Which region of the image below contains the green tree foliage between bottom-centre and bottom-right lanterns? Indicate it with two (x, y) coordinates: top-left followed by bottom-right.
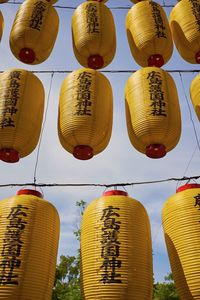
(153, 273), (180, 300)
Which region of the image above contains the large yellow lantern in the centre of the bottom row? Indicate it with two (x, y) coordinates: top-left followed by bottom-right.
(81, 190), (153, 300)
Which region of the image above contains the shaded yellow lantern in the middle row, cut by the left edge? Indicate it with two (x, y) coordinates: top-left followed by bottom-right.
(0, 69), (44, 162)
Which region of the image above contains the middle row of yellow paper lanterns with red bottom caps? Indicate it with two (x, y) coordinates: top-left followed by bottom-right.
(0, 67), (200, 162)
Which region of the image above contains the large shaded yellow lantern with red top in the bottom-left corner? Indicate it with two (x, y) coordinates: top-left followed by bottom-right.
(0, 190), (60, 300)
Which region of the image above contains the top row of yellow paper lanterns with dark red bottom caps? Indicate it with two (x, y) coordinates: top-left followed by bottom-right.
(1, 0), (200, 69)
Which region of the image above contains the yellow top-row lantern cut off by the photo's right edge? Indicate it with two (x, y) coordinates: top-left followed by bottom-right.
(170, 0), (200, 64)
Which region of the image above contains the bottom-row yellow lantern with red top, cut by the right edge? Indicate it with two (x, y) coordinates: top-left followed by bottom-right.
(162, 184), (200, 300)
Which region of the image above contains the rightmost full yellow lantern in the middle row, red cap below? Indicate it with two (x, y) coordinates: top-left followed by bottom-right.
(125, 67), (181, 158)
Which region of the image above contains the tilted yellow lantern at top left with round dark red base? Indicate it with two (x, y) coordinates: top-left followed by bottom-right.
(10, 0), (59, 64)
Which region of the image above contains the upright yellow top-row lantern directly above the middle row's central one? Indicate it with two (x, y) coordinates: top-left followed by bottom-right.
(72, 1), (116, 69)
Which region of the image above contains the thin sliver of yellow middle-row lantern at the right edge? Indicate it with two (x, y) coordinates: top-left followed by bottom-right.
(190, 74), (200, 121)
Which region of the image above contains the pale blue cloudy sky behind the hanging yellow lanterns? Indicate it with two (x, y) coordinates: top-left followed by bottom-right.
(0, 0), (200, 282)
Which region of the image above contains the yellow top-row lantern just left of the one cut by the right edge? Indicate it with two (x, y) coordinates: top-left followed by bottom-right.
(126, 1), (173, 67)
